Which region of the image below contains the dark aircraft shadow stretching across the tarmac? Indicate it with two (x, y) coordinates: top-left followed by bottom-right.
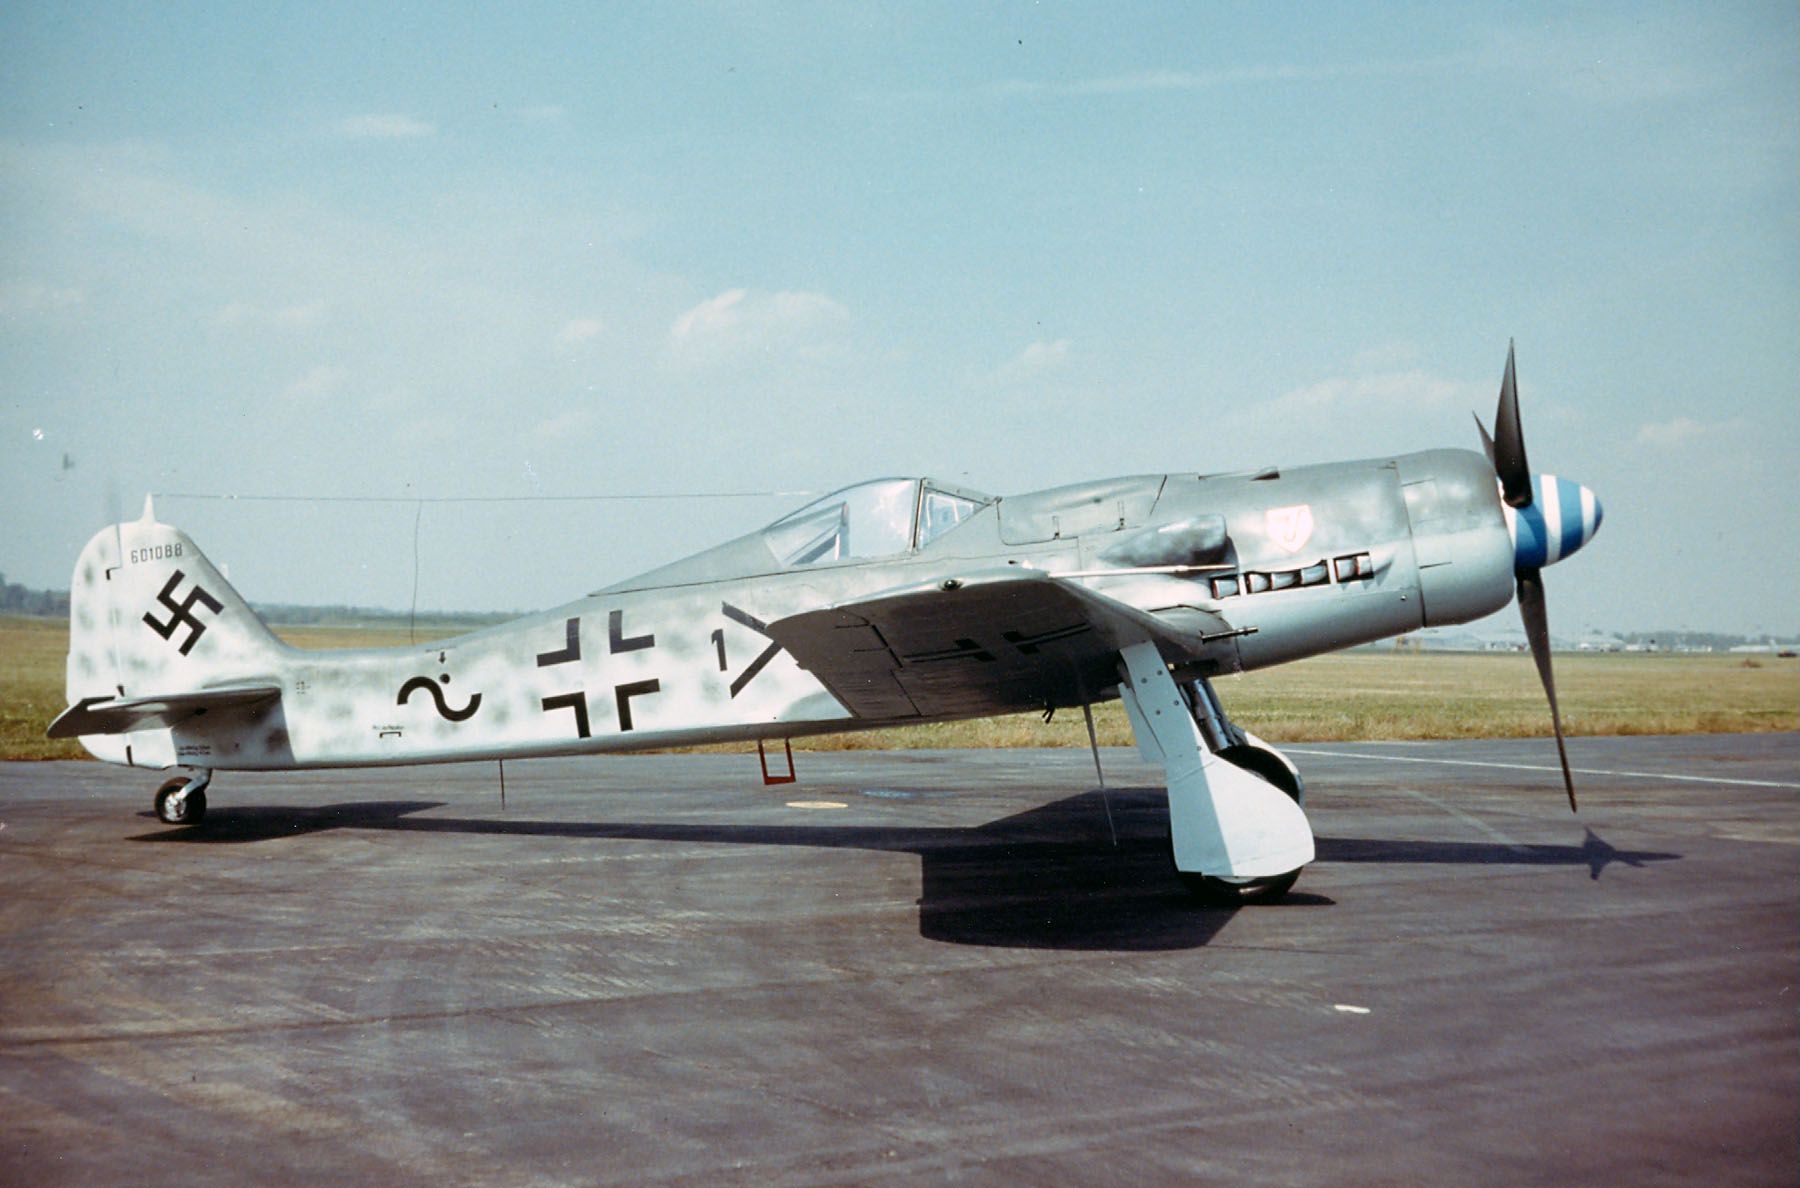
(135, 788), (1681, 950)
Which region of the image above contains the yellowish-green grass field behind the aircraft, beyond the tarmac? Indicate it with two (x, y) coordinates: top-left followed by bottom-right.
(0, 616), (1800, 760)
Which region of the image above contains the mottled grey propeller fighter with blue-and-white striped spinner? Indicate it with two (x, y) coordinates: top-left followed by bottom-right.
(49, 349), (1600, 902)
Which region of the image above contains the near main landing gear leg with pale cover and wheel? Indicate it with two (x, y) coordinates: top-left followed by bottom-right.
(1120, 643), (1312, 905)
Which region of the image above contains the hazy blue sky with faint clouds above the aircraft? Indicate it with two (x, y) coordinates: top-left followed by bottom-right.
(0, 4), (1800, 634)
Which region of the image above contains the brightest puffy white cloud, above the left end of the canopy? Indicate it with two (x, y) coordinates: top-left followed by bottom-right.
(668, 288), (850, 364)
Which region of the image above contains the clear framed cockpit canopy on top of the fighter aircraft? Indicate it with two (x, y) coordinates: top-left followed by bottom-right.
(763, 479), (994, 567)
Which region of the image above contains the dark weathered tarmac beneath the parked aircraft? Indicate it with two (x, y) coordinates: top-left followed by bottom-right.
(0, 734), (1800, 1184)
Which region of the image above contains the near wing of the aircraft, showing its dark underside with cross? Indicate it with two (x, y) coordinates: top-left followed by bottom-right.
(769, 569), (1233, 720)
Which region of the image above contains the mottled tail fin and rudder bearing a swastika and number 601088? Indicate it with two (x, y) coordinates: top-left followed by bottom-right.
(67, 499), (283, 767)
